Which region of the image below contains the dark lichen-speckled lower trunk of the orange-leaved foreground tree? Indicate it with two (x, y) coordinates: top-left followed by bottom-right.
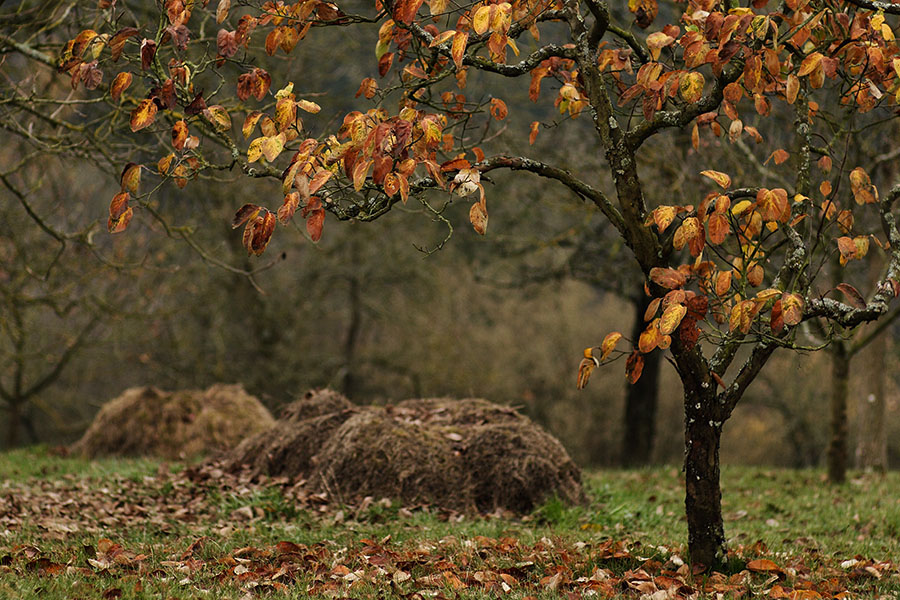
(684, 382), (725, 568)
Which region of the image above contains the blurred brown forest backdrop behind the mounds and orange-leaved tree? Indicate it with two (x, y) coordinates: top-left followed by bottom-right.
(0, 3), (900, 467)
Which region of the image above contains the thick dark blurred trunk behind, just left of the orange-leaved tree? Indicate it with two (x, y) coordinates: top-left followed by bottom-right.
(621, 288), (662, 467)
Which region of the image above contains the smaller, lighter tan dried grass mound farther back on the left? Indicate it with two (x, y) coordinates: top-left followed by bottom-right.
(72, 384), (275, 459)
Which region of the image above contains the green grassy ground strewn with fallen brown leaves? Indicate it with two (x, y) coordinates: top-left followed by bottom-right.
(0, 442), (900, 600)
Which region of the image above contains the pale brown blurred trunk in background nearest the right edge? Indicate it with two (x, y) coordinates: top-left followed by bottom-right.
(856, 332), (888, 473)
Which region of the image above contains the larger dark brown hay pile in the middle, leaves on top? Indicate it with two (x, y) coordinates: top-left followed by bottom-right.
(219, 390), (585, 513)
